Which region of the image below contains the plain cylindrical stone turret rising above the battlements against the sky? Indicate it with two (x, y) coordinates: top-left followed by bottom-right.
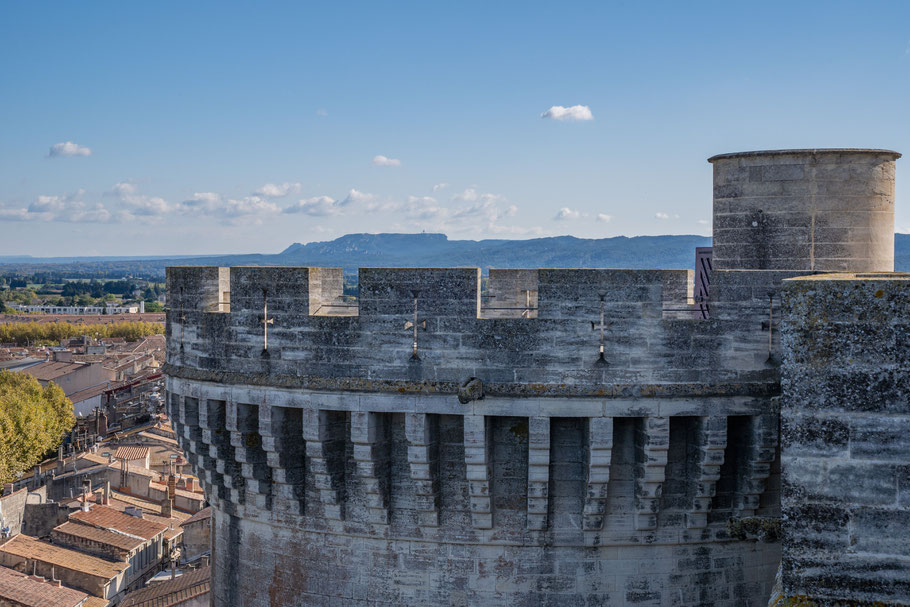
(708, 149), (901, 272)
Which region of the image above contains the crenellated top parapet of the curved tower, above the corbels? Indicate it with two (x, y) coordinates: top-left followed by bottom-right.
(167, 268), (799, 396)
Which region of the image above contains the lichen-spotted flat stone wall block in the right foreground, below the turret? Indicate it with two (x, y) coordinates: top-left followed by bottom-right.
(781, 274), (910, 605)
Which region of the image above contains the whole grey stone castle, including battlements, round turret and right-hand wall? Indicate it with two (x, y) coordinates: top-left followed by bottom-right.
(165, 149), (910, 607)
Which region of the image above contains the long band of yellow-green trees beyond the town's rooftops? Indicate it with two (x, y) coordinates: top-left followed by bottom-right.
(0, 320), (164, 346)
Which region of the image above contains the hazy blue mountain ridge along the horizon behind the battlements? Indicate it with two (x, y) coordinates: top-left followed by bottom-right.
(0, 234), (910, 273)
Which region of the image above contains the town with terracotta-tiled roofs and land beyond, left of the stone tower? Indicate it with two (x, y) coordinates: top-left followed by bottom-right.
(0, 271), (203, 607)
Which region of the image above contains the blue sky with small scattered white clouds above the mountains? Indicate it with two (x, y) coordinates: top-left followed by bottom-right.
(0, 0), (910, 255)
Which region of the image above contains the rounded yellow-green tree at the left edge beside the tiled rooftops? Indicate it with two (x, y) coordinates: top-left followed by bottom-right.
(0, 371), (76, 483)
